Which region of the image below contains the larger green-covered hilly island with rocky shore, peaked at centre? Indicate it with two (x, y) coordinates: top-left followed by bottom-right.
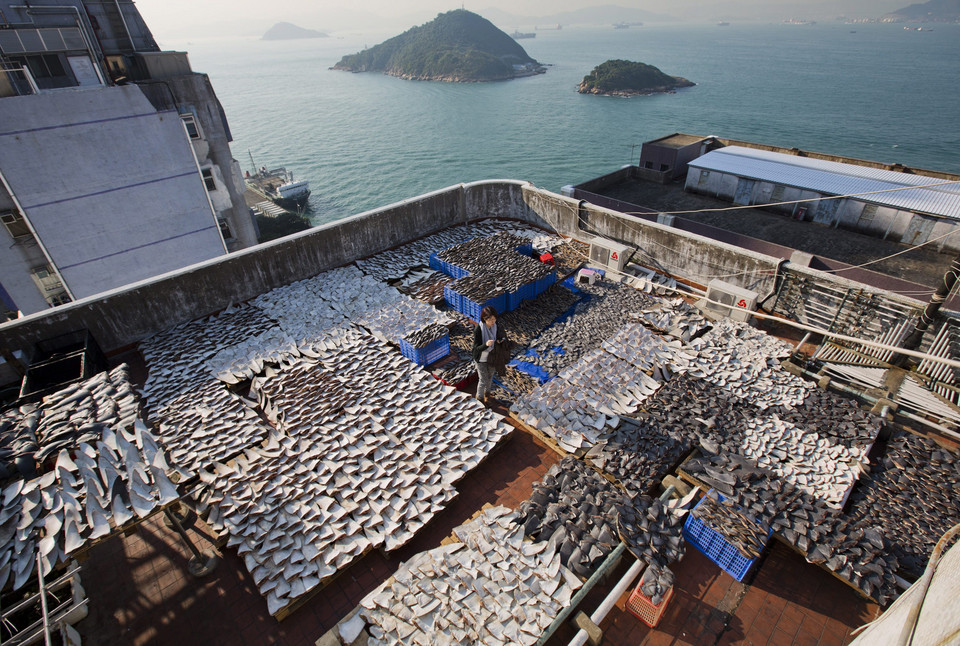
(332, 9), (545, 83)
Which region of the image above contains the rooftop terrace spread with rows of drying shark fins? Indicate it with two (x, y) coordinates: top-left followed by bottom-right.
(0, 183), (960, 644)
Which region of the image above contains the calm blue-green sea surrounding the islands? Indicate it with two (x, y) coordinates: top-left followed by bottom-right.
(172, 23), (960, 224)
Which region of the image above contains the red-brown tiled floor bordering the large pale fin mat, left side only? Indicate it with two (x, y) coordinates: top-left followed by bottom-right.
(77, 418), (560, 646)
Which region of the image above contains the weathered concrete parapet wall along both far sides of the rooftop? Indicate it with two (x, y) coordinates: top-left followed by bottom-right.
(0, 180), (928, 374)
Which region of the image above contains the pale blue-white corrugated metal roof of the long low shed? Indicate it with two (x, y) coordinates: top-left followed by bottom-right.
(688, 146), (960, 219)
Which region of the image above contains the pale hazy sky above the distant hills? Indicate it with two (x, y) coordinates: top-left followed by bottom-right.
(136, 0), (912, 45)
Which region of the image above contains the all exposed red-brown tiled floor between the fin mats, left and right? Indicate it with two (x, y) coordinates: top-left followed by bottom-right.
(77, 365), (878, 646)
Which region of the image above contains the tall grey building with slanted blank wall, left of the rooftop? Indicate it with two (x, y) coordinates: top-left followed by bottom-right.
(0, 0), (257, 320)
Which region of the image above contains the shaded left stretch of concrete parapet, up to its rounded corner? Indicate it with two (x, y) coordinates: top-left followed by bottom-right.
(0, 182), (492, 352)
